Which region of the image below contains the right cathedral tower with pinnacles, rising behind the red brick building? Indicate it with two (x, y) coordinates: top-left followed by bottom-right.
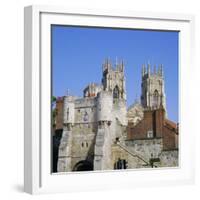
(141, 64), (166, 111)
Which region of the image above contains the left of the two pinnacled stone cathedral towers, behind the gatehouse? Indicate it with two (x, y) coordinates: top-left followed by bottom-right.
(102, 59), (126, 100)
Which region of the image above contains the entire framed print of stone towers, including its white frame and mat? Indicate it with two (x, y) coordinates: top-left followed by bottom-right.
(24, 6), (195, 193)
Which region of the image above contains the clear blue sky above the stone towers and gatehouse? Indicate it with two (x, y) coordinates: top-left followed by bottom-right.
(52, 26), (178, 122)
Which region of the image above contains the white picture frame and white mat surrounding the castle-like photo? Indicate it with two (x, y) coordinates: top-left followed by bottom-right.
(24, 6), (195, 194)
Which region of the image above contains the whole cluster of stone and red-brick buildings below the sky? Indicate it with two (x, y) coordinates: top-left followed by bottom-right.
(54, 59), (178, 172)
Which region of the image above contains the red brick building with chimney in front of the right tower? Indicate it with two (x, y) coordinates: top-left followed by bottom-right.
(127, 108), (178, 150)
